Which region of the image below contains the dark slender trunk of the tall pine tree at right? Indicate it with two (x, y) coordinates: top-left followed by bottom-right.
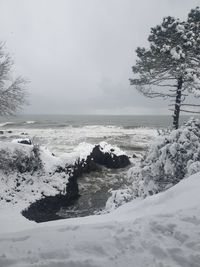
(173, 77), (183, 129)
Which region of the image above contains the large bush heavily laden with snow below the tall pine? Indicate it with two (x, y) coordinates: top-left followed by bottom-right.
(129, 119), (200, 196)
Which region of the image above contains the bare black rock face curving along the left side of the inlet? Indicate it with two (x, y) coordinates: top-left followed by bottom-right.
(22, 145), (130, 222)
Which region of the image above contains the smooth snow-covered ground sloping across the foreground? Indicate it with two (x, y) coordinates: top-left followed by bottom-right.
(0, 173), (200, 267)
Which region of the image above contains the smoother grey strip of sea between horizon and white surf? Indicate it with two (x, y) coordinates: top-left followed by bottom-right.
(0, 115), (195, 128)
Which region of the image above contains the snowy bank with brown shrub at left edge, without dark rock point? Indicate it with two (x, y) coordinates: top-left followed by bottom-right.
(0, 141), (68, 208)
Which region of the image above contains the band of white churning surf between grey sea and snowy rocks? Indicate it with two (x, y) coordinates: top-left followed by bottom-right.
(0, 125), (157, 155)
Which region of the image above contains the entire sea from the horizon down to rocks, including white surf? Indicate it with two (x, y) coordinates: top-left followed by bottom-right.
(0, 115), (195, 155)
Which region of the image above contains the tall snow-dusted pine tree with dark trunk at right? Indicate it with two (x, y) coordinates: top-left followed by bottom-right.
(130, 7), (200, 129)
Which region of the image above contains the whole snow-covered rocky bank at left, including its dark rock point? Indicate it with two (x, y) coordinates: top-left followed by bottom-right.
(0, 139), (130, 211)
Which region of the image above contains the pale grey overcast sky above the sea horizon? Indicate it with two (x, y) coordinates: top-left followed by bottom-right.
(0, 0), (200, 114)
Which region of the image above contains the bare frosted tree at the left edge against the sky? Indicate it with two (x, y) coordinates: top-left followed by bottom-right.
(0, 43), (27, 116)
